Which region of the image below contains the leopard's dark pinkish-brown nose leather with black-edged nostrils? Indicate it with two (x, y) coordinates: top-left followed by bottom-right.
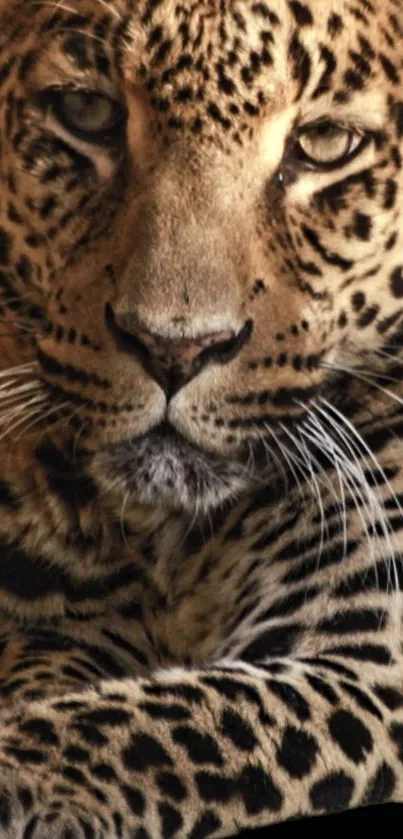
(105, 304), (253, 398)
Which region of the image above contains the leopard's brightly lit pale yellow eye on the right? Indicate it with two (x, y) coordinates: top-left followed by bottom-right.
(298, 122), (365, 169)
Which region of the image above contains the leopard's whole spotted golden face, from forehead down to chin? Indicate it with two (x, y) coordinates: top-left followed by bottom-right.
(0, 0), (403, 511)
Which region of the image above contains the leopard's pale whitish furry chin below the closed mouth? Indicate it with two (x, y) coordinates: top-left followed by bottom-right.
(98, 423), (255, 516)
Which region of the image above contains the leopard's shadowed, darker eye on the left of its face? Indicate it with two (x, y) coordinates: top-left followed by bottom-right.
(42, 89), (125, 144)
